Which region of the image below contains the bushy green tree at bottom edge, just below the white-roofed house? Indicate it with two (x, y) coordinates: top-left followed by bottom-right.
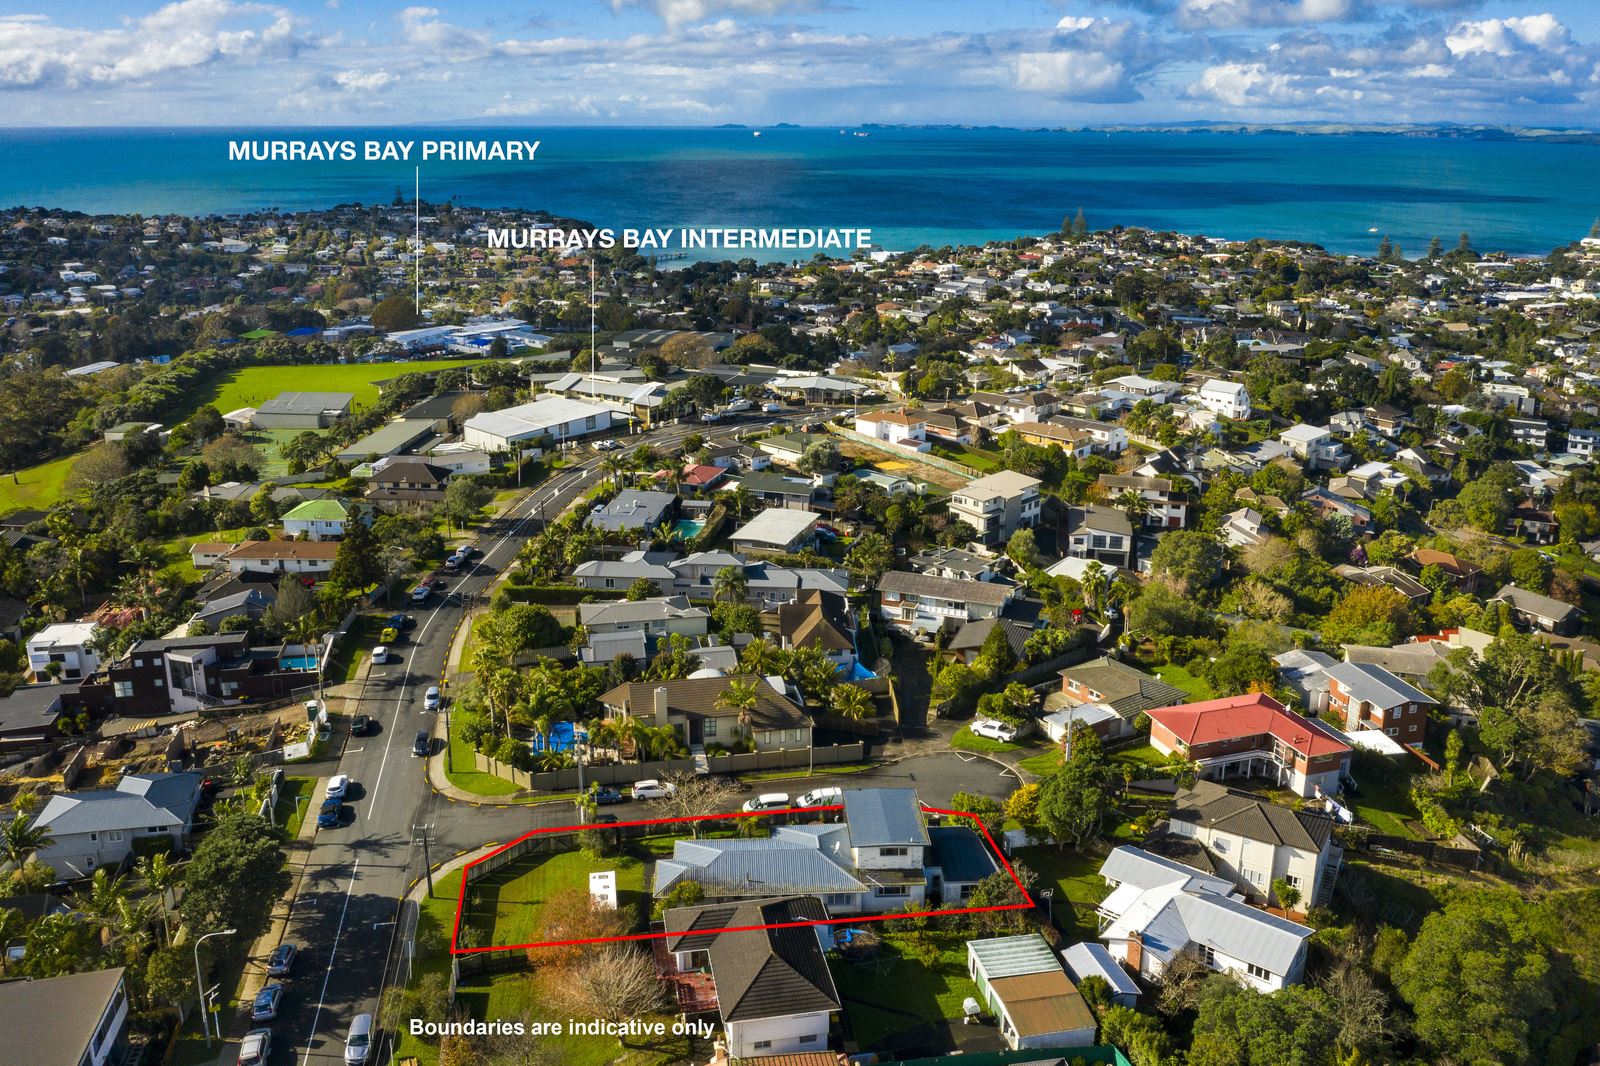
(1184, 975), (1338, 1066)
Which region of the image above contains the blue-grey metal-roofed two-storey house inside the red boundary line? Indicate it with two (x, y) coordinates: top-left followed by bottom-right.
(653, 787), (998, 916)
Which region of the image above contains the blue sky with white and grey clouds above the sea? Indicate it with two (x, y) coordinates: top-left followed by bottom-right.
(0, 0), (1600, 126)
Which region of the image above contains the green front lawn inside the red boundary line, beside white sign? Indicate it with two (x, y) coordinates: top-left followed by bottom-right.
(461, 848), (650, 946)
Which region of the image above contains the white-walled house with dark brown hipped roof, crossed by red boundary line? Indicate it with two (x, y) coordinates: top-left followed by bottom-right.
(664, 896), (840, 1061)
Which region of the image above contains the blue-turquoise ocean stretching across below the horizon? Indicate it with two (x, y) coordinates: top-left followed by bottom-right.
(0, 126), (1600, 254)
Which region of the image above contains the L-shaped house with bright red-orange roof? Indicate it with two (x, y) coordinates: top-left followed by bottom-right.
(1146, 693), (1350, 797)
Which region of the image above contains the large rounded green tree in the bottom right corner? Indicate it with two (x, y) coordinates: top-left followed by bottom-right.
(1392, 890), (1571, 1066)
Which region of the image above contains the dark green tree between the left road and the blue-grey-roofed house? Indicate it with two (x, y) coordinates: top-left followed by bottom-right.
(178, 812), (290, 944)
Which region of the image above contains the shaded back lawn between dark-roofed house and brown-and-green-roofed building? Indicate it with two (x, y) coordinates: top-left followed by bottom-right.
(829, 927), (978, 1050)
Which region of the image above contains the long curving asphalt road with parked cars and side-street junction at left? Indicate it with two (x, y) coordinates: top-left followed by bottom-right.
(265, 410), (832, 1066)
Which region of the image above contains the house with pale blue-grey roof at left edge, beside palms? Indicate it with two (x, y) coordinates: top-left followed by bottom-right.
(32, 773), (200, 880)
